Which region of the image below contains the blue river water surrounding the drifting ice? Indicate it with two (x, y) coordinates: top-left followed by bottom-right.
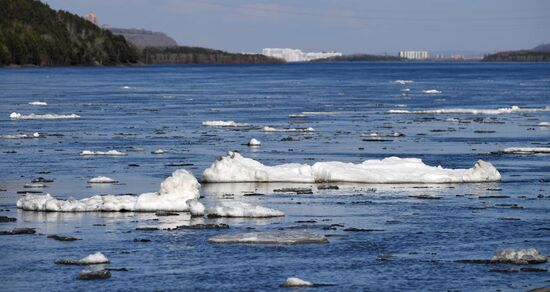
(0, 62), (550, 291)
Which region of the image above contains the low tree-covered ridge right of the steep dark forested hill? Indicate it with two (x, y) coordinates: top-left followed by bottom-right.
(140, 46), (285, 64)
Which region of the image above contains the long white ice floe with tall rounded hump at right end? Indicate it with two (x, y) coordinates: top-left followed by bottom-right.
(17, 169), (200, 212)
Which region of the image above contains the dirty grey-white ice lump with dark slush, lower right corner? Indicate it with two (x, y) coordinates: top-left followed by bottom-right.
(459, 248), (548, 265)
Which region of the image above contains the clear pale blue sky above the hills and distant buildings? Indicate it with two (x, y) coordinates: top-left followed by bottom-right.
(43, 0), (550, 54)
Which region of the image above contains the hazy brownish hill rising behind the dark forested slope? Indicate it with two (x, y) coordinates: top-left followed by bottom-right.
(109, 28), (178, 47)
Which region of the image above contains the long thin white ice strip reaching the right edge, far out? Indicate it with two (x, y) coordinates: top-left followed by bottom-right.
(388, 105), (550, 115)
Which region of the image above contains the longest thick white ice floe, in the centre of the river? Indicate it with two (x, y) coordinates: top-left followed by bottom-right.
(202, 151), (501, 183)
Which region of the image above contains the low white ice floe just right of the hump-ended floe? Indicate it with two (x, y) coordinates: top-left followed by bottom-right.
(206, 202), (285, 218)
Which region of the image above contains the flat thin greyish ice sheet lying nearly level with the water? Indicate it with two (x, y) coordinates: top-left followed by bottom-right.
(208, 231), (328, 244)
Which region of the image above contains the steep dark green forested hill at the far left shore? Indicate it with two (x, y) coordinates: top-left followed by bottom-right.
(0, 0), (138, 66)
